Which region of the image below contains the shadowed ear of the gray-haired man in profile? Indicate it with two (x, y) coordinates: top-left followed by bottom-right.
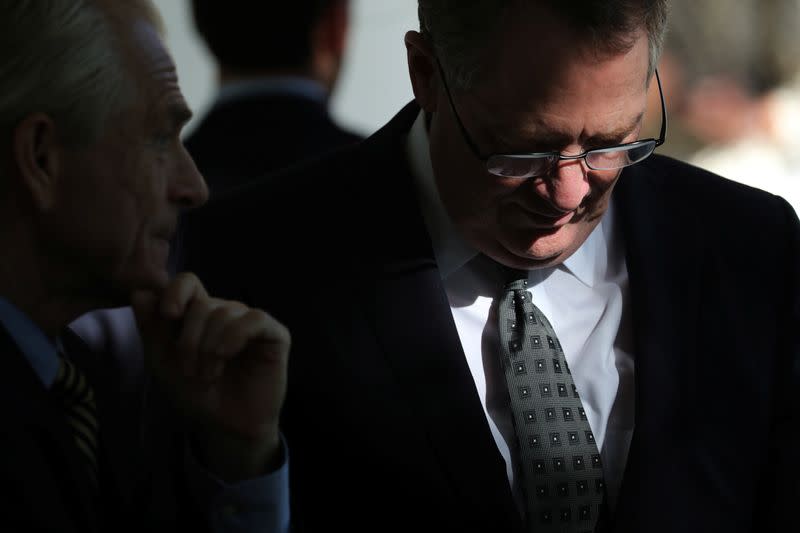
(12, 113), (61, 210)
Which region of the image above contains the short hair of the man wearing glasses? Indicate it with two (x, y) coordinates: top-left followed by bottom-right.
(418, 0), (670, 90)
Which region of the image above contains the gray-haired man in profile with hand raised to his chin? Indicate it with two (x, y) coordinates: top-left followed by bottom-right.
(0, 0), (290, 533)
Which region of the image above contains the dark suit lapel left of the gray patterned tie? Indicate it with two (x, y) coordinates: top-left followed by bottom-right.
(363, 102), (521, 531)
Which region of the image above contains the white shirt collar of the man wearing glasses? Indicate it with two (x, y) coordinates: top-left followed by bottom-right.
(406, 111), (614, 287)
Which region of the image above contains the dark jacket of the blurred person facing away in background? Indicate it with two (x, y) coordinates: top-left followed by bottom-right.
(185, 89), (360, 194)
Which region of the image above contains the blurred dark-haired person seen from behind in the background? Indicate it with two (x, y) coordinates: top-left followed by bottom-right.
(186, 0), (359, 196)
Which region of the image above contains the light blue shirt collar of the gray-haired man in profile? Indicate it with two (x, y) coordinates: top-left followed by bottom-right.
(0, 297), (59, 389)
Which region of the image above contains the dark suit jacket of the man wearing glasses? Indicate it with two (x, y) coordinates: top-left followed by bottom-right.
(185, 104), (800, 533)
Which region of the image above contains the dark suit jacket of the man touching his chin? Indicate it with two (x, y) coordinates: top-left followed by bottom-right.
(0, 326), (204, 533)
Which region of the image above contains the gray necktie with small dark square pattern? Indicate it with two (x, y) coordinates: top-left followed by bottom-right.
(497, 272), (605, 533)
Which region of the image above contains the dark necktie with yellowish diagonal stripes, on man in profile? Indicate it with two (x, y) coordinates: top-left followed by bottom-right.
(52, 354), (97, 486)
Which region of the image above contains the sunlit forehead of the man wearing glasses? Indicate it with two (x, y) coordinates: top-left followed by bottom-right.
(471, 30), (649, 145)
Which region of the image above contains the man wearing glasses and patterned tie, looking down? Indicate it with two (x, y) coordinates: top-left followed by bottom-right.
(186, 0), (800, 533)
